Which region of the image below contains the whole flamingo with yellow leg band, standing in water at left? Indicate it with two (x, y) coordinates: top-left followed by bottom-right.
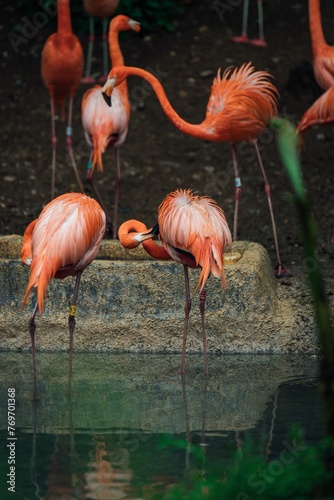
(21, 193), (106, 400)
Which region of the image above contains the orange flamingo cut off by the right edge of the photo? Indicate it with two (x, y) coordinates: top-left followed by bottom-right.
(297, 0), (334, 133)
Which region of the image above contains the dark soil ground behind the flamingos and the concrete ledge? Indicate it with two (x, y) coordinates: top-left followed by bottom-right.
(0, 0), (334, 289)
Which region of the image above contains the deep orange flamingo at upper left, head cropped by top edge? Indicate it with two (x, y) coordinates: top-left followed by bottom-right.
(41, 0), (84, 198)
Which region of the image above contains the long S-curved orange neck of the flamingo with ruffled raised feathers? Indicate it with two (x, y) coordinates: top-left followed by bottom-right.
(115, 66), (215, 141)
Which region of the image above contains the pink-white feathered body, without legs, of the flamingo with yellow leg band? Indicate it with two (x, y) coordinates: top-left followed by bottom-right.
(23, 193), (106, 311)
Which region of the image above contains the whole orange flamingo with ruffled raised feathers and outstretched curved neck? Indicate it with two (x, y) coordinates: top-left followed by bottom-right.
(103, 63), (290, 277)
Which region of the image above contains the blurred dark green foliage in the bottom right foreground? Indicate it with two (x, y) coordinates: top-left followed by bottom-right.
(152, 426), (334, 500)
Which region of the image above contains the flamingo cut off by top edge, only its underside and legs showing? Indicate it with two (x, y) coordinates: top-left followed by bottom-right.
(81, 0), (119, 83)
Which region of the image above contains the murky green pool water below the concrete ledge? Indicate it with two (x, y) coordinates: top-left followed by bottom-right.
(0, 352), (323, 500)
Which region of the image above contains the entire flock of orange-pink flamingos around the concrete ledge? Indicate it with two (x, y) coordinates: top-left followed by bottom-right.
(21, 0), (334, 400)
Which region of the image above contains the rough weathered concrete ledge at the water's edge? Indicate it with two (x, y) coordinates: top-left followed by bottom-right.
(0, 236), (318, 353)
